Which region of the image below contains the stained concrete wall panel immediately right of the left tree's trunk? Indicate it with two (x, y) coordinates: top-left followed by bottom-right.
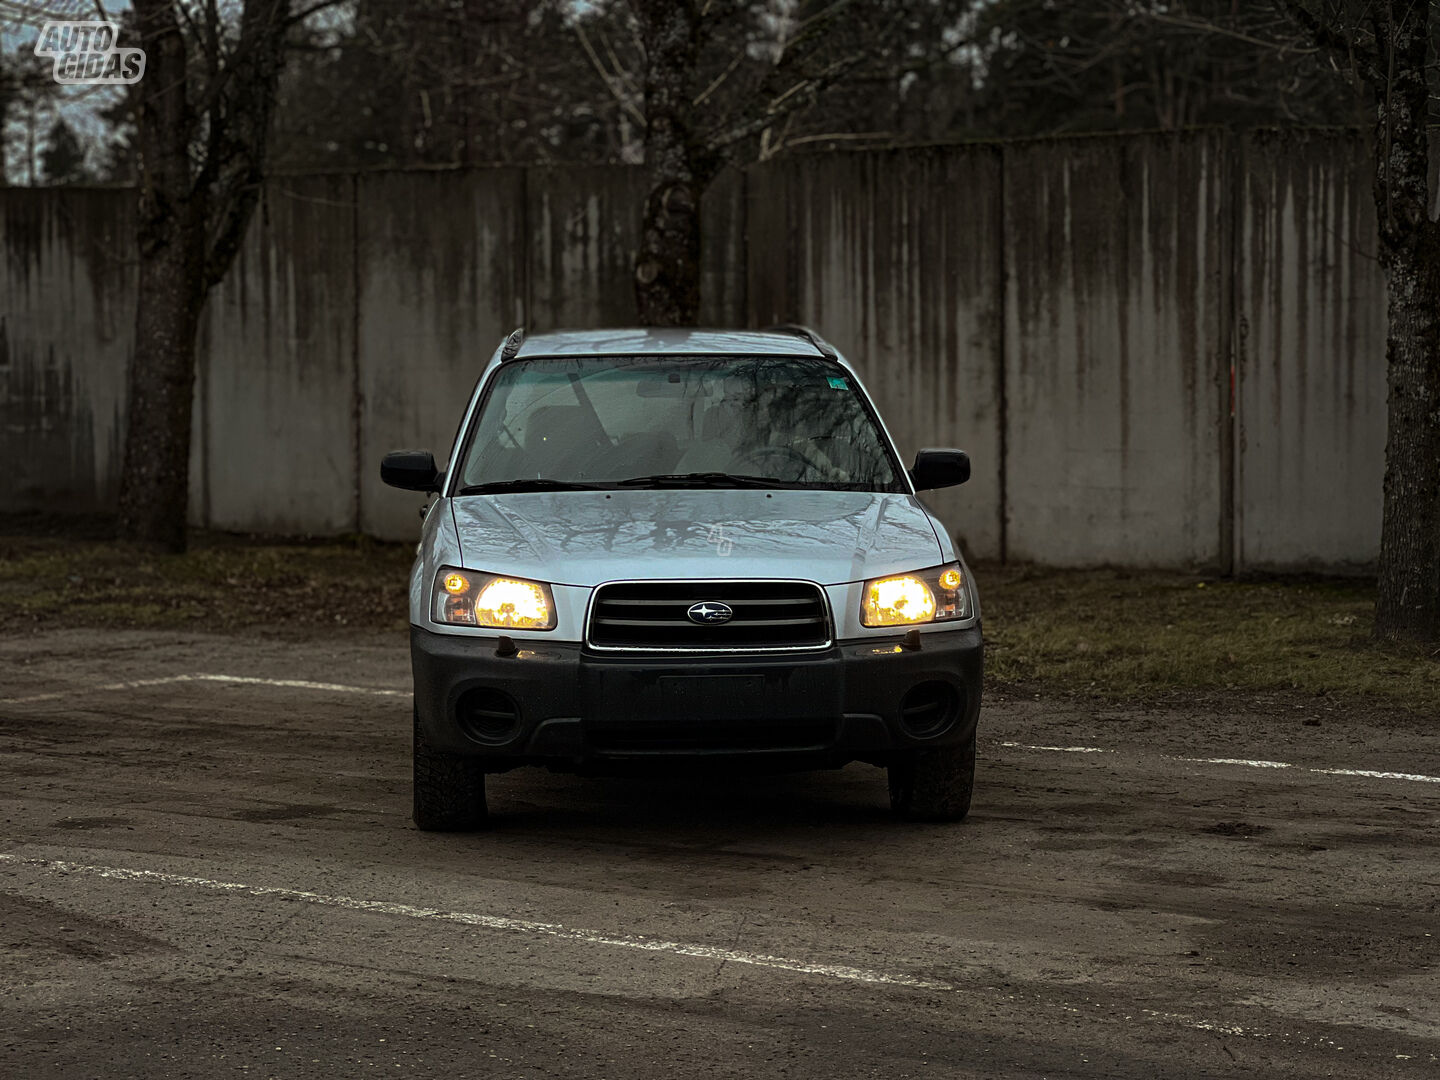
(192, 176), (357, 534)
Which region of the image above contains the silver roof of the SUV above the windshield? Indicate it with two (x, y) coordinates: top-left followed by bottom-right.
(513, 327), (835, 360)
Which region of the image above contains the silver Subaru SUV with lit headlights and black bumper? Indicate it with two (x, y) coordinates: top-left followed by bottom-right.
(380, 327), (982, 829)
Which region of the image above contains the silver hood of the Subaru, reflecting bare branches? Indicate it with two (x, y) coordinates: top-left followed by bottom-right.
(451, 488), (942, 586)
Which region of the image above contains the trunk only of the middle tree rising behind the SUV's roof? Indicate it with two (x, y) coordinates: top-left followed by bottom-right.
(634, 0), (713, 327)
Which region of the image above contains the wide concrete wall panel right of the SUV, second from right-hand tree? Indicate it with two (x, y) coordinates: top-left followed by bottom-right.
(1004, 135), (1230, 566)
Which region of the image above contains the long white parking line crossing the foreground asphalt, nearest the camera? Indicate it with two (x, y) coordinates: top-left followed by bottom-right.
(0, 854), (958, 991)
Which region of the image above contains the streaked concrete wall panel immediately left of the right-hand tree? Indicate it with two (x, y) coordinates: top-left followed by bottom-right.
(1236, 134), (1385, 569)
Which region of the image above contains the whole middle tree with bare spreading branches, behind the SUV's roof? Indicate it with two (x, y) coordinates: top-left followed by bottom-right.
(593, 0), (944, 325)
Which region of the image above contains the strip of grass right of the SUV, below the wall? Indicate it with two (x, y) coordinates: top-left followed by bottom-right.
(978, 566), (1440, 716)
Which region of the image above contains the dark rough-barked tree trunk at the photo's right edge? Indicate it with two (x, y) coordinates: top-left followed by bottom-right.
(1375, 0), (1440, 645)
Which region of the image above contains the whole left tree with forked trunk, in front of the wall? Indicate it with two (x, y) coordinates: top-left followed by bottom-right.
(118, 0), (306, 550)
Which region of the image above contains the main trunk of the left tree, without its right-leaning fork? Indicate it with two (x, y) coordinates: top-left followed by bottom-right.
(118, 0), (206, 552)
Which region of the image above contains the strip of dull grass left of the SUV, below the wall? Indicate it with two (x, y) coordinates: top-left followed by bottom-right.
(0, 528), (415, 632)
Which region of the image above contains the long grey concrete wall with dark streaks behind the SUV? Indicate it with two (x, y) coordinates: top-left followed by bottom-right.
(0, 132), (1385, 569)
